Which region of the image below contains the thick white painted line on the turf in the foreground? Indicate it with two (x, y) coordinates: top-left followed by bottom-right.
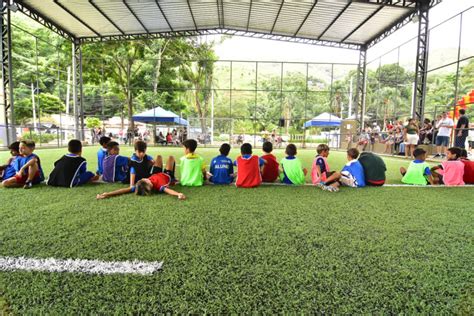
(0, 257), (163, 275)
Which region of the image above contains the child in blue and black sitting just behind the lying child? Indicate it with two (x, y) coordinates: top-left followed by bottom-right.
(122, 140), (156, 186)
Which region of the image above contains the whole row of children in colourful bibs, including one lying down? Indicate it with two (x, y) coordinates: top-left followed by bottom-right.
(0, 136), (474, 199)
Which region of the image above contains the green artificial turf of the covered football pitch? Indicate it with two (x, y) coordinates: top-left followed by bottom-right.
(0, 148), (474, 314)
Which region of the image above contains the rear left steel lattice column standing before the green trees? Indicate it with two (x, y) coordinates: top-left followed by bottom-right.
(72, 40), (84, 141)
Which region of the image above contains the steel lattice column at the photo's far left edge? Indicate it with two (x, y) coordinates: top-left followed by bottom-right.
(0, 0), (16, 146)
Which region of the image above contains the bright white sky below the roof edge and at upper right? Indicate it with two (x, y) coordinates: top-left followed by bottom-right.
(209, 0), (474, 63)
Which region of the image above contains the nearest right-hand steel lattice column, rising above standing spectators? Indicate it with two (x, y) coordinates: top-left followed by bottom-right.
(412, 0), (430, 121)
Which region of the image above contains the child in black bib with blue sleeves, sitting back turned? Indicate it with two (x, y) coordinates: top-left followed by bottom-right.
(48, 139), (99, 188)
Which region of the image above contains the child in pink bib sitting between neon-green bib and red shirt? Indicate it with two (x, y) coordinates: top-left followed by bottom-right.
(431, 147), (464, 186)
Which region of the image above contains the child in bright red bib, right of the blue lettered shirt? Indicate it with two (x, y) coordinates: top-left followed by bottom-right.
(234, 143), (265, 188)
